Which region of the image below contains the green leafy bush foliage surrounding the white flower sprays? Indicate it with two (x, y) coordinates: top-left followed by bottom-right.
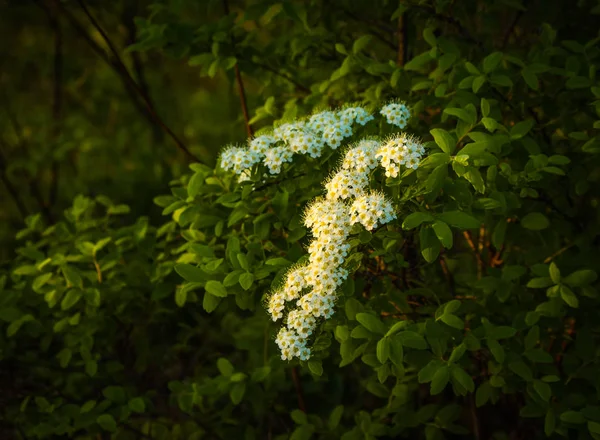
(0, 1), (600, 440)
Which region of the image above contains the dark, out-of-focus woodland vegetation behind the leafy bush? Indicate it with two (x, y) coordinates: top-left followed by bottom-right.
(0, 0), (597, 260)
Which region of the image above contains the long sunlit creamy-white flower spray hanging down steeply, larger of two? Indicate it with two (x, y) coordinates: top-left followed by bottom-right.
(268, 135), (423, 360)
